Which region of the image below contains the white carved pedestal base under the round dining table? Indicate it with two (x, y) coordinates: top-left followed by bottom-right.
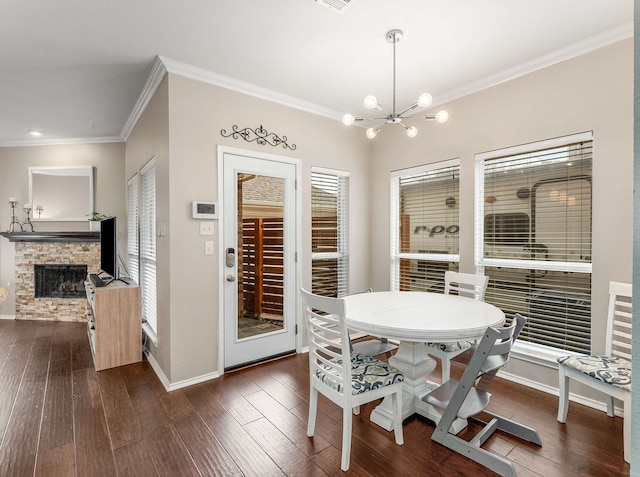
(371, 341), (467, 434)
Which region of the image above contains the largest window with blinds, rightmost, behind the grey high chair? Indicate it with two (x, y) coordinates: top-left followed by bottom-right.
(475, 133), (592, 353)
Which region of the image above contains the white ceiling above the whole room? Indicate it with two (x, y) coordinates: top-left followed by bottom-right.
(0, 0), (633, 146)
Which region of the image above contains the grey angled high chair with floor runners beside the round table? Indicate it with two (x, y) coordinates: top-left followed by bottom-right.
(423, 315), (542, 477)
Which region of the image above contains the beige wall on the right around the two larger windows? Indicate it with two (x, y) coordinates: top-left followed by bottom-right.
(370, 40), (633, 390)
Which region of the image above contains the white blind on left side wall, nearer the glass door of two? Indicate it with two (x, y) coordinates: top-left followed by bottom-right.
(140, 159), (158, 333)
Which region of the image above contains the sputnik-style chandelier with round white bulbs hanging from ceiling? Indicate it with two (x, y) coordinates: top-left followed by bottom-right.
(342, 30), (449, 139)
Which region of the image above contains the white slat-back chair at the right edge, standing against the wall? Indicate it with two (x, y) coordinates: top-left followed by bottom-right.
(558, 282), (632, 462)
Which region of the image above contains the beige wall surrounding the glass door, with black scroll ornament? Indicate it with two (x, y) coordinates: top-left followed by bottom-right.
(127, 74), (371, 385)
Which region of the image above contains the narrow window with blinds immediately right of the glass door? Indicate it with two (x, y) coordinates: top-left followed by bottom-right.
(311, 168), (349, 297)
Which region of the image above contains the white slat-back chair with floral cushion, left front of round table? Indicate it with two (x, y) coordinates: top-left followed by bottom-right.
(300, 289), (404, 471)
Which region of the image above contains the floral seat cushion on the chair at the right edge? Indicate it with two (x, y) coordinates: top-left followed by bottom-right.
(558, 356), (631, 391)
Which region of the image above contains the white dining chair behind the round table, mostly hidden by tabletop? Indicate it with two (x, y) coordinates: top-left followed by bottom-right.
(427, 270), (489, 383)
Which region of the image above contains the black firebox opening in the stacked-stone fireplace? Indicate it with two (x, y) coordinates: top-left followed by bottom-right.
(33, 264), (87, 298)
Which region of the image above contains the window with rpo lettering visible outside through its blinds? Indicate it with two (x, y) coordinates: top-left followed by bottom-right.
(391, 159), (460, 292)
